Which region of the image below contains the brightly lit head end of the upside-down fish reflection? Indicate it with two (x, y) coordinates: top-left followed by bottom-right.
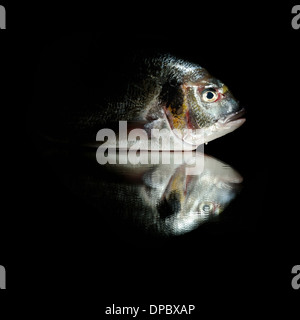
(132, 153), (242, 235)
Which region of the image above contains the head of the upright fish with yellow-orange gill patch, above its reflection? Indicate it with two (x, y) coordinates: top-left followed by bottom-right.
(165, 67), (245, 146)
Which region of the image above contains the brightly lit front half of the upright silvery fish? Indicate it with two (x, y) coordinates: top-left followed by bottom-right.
(94, 55), (245, 150)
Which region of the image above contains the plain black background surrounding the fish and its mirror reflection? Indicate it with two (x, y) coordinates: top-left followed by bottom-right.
(0, 2), (300, 317)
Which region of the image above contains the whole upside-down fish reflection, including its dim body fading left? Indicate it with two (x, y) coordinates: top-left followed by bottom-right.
(46, 152), (242, 236)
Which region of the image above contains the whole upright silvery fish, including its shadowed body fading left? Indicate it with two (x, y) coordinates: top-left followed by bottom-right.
(32, 42), (245, 150)
